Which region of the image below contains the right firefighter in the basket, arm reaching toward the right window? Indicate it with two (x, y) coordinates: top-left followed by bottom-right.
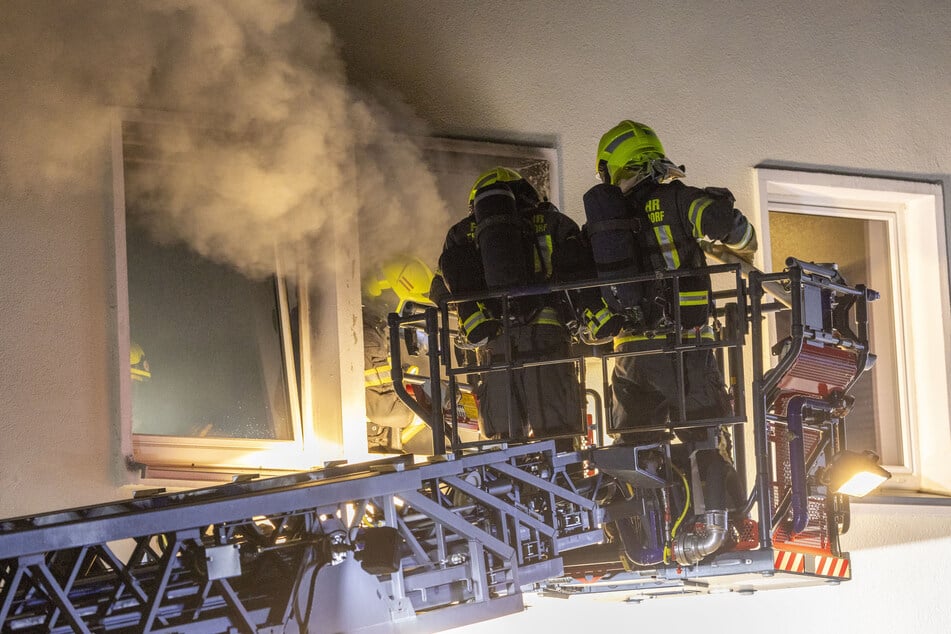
(584, 120), (757, 508)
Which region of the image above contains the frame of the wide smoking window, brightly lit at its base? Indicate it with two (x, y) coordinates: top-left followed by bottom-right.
(112, 109), (561, 486)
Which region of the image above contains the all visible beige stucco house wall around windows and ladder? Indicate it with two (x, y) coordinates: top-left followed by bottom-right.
(0, 0), (951, 632)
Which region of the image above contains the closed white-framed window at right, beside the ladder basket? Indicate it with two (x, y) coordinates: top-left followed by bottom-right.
(758, 169), (951, 494)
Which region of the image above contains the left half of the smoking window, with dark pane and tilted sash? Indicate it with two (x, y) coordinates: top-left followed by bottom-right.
(113, 112), (309, 479)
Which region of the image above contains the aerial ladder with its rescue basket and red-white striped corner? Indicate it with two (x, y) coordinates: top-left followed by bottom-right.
(0, 259), (875, 634)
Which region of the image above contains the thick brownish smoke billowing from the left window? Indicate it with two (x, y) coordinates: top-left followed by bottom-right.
(0, 0), (448, 277)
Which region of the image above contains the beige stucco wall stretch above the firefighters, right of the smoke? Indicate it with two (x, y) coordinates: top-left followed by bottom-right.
(318, 0), (951, 222)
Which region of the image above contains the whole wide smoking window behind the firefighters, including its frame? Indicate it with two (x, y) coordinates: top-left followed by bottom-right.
(113, 111), (558, 480)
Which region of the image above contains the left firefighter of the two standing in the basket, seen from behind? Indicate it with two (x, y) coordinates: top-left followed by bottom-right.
(430, 167), (622, 450)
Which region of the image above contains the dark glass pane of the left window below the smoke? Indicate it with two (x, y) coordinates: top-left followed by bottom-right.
(126, 163), (294, 440)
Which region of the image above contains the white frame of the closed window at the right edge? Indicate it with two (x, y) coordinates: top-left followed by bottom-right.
(755, 169), (951, 494)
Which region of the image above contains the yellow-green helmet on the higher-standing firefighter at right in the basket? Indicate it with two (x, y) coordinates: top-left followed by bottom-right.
(597, 119), (667, 185)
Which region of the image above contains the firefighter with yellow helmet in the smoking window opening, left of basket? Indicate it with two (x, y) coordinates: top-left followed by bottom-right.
(363, 256), (433, 453)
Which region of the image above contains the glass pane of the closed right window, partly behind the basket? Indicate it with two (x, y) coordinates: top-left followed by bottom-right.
(769, 211), (903, 465)
